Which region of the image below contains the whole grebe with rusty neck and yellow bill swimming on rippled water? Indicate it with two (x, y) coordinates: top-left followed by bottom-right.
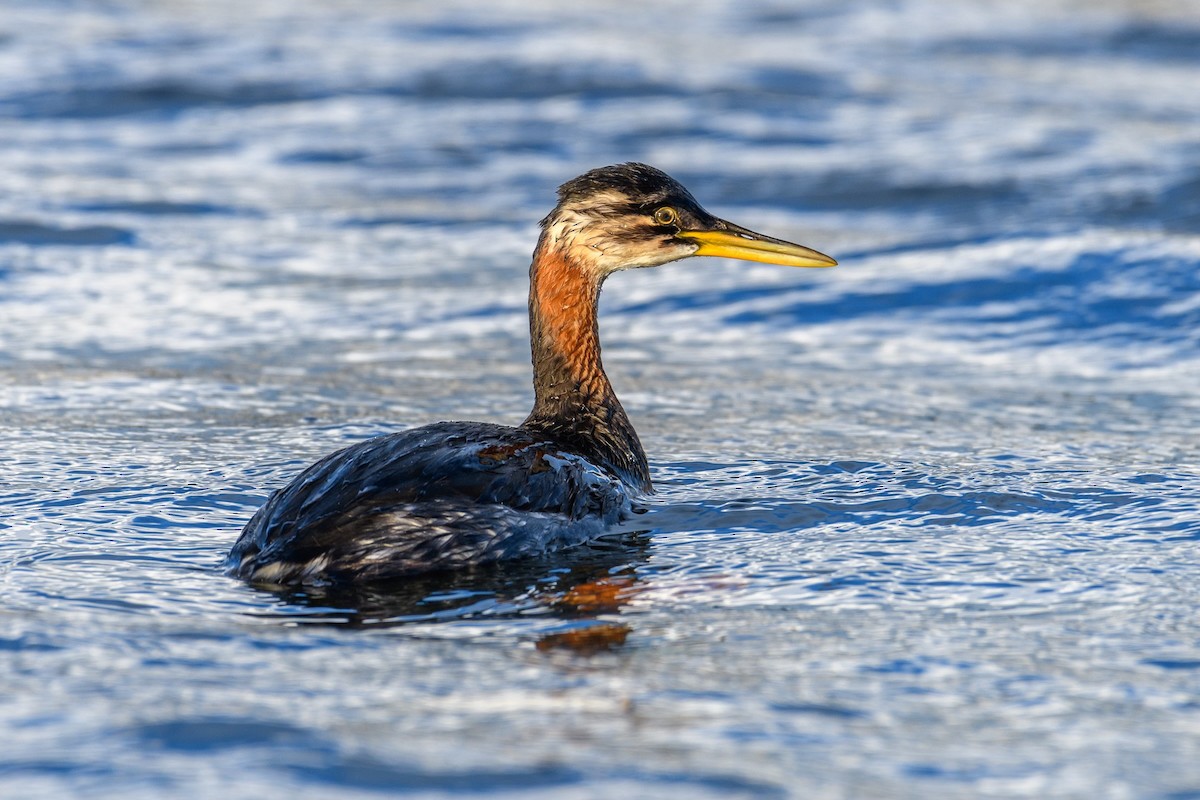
(226, 163), (836, 584)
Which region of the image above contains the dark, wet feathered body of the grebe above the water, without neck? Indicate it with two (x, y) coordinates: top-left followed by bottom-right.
(226, 422), (630, 583)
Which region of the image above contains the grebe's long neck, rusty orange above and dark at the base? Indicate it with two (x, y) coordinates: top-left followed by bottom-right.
(522, 234), (650, 491)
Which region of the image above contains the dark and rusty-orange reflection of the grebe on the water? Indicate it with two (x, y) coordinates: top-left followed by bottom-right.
(247, 531), (649, 655)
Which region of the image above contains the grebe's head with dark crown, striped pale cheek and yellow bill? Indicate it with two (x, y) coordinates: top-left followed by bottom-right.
(541, 163), (838, 279)
